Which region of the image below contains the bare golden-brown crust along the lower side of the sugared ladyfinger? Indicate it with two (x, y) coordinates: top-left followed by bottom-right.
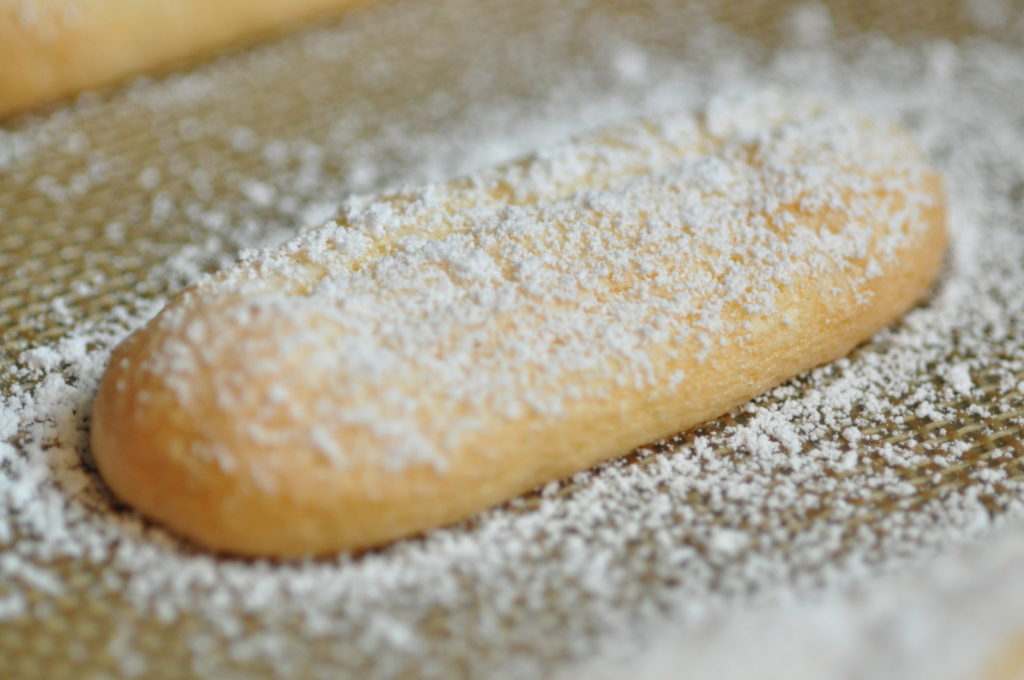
(92, 96), (946, 556)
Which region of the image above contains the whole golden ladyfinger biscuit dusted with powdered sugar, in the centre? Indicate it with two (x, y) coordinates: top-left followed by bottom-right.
(92, 94), (946, 556)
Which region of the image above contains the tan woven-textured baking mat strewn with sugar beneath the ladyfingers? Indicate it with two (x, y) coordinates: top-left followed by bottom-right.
(0, 0), (1024, 678)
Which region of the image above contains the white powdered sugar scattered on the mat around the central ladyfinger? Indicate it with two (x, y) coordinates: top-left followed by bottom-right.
(0, 0), (1024, 677)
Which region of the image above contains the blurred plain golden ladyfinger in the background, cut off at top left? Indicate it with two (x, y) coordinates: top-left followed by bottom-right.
(0, 0), (360, 117)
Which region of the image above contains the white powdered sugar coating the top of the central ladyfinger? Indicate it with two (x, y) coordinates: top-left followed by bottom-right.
(121, 94), (938, 475)
